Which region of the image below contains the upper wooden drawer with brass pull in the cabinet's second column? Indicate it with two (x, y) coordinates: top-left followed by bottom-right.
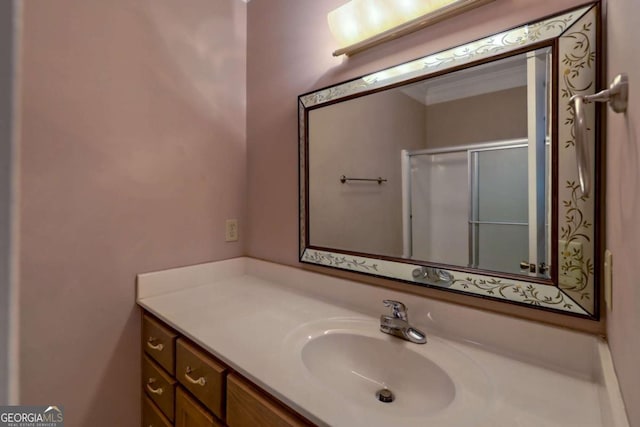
(176, 338), (227, 419)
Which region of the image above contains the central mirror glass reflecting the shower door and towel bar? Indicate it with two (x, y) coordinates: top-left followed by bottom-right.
(308, 47), (551, 278)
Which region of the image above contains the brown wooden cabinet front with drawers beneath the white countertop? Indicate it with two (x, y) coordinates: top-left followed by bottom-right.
(142, 312), (314, 427)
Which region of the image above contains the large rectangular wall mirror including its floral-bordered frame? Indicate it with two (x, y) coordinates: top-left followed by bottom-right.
(299, 4), (600, 318)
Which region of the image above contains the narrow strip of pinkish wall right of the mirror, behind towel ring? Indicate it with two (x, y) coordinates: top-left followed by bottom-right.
(607, 0), (640, 427)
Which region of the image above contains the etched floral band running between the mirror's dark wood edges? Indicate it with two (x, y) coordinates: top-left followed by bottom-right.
(298, 4), (598, 317)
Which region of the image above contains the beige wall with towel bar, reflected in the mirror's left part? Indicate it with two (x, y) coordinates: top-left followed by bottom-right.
(308, 90), (425, 256)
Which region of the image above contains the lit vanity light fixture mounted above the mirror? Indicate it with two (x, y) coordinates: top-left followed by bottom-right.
(327, 0), (494, 56)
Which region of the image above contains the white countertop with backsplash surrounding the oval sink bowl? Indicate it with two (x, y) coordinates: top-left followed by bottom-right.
(138, 258), (627, 427)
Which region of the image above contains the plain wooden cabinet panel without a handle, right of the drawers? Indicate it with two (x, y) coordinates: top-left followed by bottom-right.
(227, 374), (313, 427)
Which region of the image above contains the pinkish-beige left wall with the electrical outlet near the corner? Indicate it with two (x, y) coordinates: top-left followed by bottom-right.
(20, 0), (246, 427)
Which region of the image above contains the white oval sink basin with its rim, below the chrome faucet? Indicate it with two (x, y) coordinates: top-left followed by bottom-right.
(284, 318), (494, 427)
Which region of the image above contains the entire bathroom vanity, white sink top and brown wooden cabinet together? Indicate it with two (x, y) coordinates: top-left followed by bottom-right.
(137, 258), (628, 427)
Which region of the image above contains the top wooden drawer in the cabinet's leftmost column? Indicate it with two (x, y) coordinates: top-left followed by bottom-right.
(142, 314), (177, 375)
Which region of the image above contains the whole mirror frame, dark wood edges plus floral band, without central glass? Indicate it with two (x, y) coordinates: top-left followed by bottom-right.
(298, 3), (604, 320)
